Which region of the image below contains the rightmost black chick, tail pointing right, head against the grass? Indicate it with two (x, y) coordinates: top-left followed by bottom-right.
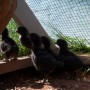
(56, 39), (86, 79)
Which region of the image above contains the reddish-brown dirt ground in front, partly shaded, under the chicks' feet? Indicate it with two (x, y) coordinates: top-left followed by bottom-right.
(0, 67), (90, 90)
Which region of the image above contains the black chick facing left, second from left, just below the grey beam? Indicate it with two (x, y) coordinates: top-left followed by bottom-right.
(16, 26), (32, 49)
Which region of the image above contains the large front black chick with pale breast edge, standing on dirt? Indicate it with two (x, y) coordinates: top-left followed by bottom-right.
(30, 33), (61, 83)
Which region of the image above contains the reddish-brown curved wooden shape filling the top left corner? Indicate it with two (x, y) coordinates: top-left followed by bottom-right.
(0, 0), (17, 33)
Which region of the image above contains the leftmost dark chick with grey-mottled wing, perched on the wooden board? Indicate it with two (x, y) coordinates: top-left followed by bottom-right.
(0, 28), (19, 61)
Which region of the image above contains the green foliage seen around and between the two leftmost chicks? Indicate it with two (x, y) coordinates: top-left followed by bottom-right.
(0, 19), (30, 59)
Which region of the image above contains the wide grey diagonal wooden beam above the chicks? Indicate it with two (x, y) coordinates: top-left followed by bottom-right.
(14, 0), (48, 36)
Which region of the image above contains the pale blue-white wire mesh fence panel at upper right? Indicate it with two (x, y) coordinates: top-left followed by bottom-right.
(25, 0), (90, 44)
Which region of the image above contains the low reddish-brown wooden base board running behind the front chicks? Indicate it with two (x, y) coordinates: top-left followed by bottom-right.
(0, 55), (90, 75)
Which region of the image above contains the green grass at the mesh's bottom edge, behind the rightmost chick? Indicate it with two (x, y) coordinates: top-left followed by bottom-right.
(51, 26), (90, 53)
